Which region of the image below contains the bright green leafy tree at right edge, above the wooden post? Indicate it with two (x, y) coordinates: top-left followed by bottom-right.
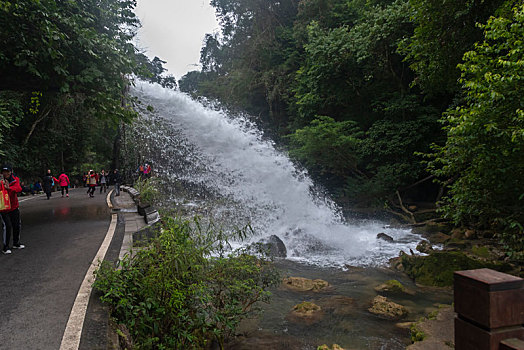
(429, 5), (524, 252)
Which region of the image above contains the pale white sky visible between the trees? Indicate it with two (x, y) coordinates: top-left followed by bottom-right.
(135, 0), (219, 80)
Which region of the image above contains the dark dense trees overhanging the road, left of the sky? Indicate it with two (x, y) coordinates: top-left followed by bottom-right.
(0, 0), (176, 179)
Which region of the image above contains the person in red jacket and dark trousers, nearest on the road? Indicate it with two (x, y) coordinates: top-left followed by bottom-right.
(0, 165), (25, 254)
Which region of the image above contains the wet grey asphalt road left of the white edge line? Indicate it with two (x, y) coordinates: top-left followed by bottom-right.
(0, 188), (116, 349)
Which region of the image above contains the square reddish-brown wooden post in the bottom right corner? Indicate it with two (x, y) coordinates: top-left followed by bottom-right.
(454, 269), (524, 350)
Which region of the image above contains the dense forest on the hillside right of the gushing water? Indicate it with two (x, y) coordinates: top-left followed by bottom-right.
(179, 0), (524, 258)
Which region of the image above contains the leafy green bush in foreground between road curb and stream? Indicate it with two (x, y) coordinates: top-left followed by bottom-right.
(94, 219), (279, 349)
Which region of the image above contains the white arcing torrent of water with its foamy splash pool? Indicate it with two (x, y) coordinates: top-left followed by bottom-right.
(133, 82), (420, 267)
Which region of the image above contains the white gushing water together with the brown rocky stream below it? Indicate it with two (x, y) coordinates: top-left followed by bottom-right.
(126, 81), (452, 350)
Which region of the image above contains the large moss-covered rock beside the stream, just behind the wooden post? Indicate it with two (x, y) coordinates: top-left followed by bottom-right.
(401, 251), (512, 287)
